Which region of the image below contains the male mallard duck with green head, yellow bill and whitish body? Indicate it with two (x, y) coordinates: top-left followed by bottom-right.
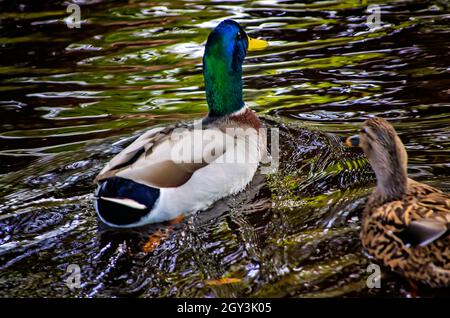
(91, 20), (267, 227)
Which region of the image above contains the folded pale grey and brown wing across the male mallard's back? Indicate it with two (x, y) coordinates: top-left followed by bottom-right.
(95, 124), (226, 188)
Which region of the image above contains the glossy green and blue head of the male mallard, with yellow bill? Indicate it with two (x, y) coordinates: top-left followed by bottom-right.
(203, 20), (267, 117)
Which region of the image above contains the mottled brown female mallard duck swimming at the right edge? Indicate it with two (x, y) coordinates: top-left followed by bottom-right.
(346, 118), (450, 287)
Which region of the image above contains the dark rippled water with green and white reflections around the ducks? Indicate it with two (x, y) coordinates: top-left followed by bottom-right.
(0, 0), (450, 297)
